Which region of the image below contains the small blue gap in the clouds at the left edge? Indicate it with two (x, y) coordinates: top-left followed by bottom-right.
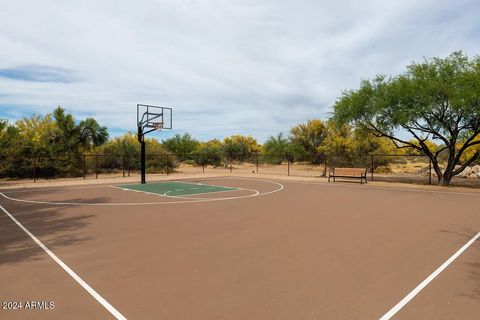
(0, 65), (76, 83)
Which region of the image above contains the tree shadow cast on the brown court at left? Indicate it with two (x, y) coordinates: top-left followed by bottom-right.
(0, 198), (105, 265)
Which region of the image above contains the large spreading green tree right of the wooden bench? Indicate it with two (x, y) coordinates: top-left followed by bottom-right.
(333, 52), (480, 186)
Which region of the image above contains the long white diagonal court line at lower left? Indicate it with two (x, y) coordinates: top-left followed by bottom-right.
(0, 205), (127, 320)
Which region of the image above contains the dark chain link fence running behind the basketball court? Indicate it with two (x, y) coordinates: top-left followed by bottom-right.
(0, 153), (480, 187)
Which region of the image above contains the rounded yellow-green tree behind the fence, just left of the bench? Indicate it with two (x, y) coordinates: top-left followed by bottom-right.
(290, 119), (327, 164)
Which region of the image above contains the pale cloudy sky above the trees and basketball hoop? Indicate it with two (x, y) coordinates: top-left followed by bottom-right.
(0, 0), (480, 142)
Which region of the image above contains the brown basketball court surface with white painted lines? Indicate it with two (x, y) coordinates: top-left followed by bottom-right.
(0, 177), (480, 319)
